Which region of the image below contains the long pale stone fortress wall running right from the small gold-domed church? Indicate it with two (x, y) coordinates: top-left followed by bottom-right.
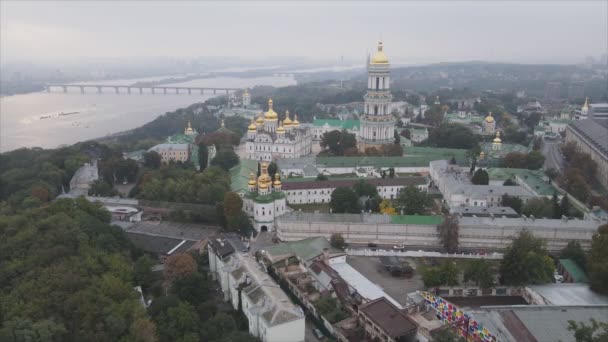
(276, 214), (601, 251)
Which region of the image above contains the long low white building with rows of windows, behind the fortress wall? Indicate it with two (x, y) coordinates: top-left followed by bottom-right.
(283, 177), (429, 204)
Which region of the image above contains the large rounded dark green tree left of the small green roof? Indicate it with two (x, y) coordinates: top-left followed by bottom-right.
(500, 230), (555, 286)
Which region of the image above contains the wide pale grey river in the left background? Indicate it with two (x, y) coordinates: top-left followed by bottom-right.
(0, 76), (296, 152)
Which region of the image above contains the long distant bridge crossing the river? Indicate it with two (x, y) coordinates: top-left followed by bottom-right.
(45, 84), (239, 95)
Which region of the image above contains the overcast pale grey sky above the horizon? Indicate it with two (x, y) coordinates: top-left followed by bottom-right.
(0, 0), (608, 63)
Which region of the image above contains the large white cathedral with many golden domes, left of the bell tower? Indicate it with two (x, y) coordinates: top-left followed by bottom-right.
(245, 99), (312, 162)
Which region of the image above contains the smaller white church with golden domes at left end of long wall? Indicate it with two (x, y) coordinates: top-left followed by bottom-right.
(243, 162), (287, 231)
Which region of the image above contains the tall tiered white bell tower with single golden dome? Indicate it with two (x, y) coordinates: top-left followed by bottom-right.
(358, 42), (396, 151)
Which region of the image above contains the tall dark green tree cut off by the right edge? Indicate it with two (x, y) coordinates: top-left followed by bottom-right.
(587, 224), (608, 294)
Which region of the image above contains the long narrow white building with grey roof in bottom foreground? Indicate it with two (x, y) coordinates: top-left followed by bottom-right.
(208, 237), (306, 342)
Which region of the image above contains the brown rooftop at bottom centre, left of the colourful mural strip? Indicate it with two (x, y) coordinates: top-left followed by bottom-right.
(359, 297), (417, 339)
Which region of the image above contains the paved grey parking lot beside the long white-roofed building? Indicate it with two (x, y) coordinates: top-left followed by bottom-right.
(346, 256), (424, 305)
